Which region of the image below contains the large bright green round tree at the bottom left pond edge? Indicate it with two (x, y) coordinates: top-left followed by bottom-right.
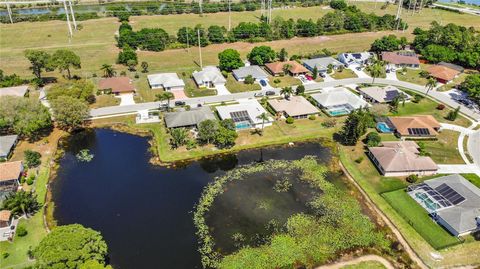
(33, 224), (108, 269)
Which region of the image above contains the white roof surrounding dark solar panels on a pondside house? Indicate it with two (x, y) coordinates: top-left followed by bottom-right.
(216, 99), (273, 124)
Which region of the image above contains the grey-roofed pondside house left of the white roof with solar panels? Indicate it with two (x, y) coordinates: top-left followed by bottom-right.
(165, 106), (215, 128)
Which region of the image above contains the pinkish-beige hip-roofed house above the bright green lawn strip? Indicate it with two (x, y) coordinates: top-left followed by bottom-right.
(368, 141), (438, 177)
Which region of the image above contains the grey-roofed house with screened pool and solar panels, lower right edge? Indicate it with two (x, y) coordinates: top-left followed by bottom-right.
(407, 174), (480, 236)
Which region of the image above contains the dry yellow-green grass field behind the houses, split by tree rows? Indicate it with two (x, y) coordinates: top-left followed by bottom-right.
(0, 2), (480, 77)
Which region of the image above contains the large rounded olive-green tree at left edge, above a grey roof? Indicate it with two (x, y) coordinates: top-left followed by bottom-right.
(0, 96), (52, 138)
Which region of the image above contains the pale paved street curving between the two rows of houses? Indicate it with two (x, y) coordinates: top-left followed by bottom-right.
(90, 78), (480, 121)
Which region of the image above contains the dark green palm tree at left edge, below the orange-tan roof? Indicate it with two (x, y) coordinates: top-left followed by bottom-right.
(2, 190), (41, 218)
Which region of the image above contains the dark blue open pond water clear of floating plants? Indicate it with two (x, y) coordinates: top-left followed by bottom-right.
(52, 129), (330, 269)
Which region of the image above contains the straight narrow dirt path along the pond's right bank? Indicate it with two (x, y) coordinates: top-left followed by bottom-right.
(338, 159), (428, 269)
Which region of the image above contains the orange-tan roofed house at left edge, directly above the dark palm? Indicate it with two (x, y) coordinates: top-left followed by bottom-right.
(0, 161), (23, 201)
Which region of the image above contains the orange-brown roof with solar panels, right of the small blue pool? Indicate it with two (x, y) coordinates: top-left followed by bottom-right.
(388, 115), (440, 136)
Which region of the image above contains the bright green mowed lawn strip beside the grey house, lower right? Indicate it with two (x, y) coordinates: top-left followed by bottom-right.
(382, 189), (460, 249)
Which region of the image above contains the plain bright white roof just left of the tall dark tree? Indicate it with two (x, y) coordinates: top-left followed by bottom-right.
(311, 88), (368, 109)
